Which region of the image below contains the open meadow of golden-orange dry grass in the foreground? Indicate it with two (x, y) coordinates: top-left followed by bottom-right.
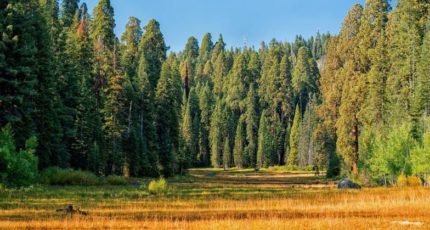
(0, 170), (430, 229)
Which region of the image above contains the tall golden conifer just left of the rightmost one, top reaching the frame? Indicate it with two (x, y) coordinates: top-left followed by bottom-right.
(357, 0), (390, 129)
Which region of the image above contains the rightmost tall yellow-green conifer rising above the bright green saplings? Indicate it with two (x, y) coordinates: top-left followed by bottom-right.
(385, 0), (424, 123)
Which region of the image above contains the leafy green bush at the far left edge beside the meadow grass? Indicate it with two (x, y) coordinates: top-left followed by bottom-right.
(0, 125), (38, 187)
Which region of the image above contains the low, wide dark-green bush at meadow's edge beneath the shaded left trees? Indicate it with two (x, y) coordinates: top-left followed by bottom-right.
(40, 167), (100, 186)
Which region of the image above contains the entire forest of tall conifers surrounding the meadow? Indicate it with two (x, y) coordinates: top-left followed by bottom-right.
(0, 0), (430, 185)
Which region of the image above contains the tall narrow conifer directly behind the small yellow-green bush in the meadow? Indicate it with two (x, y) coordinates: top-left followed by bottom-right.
(155, 54), (182, 176)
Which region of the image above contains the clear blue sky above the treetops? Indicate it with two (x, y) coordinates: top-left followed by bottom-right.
(81, 0), (364, 51)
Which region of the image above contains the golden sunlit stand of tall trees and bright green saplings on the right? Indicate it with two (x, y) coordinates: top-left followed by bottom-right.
(317, 0), (430, 183)
